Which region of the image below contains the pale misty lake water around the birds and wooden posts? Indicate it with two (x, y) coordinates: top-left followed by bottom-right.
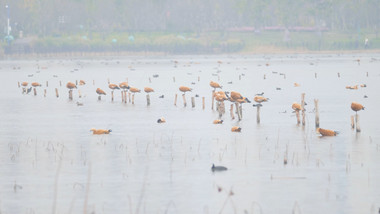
(0, 54), (380, 213)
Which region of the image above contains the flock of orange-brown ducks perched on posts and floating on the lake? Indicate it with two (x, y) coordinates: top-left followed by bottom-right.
(21, 77), (366, 136)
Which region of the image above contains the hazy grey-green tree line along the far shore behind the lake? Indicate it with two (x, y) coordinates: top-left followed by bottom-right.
(0, 0), (380, 36)
